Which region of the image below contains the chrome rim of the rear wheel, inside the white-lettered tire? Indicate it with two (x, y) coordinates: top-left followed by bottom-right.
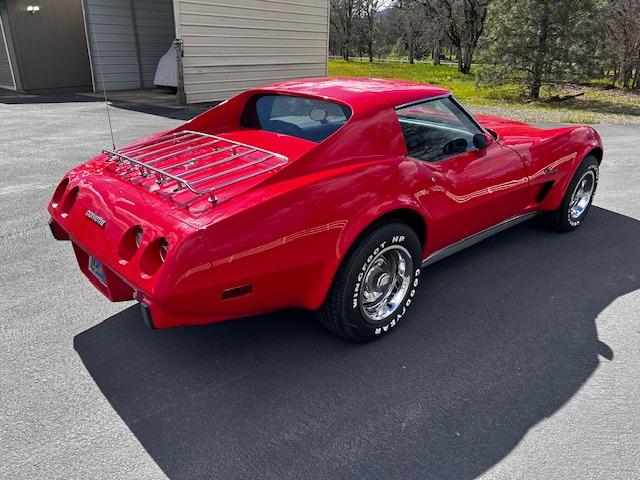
(358, 245), (413, 322)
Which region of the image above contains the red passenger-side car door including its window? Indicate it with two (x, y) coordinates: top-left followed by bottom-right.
(396, 97), (530, 253)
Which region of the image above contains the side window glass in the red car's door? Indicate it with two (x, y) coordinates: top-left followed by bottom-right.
(396, 97), (480, 162)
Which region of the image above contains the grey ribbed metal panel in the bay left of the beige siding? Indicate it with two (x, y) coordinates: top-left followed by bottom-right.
(83, 0), (175, 91)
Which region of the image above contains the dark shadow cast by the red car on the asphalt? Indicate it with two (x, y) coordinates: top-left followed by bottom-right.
(74, 207), (640, 480)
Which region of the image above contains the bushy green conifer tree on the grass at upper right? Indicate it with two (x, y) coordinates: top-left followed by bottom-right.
(478, 0), (599, 99)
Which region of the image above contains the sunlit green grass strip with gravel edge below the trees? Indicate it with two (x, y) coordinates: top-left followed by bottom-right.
(329, 60), (640, 123)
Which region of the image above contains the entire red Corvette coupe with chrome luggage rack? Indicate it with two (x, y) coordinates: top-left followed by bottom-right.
(49, 78), (602, 341)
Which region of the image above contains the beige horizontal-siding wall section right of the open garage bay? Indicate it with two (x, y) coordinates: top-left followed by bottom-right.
(174, 0), (329, 103)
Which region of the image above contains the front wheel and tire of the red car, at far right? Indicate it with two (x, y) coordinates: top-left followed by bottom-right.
(544, 155), (599, 232)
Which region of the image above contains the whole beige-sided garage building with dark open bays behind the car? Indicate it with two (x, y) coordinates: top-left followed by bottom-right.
(0, 0), (329, 103)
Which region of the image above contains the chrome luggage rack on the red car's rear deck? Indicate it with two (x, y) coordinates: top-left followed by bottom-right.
(102, 130), (289, 207)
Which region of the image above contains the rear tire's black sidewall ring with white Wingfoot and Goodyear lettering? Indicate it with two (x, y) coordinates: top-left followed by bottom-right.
(343, 223), (422, 339)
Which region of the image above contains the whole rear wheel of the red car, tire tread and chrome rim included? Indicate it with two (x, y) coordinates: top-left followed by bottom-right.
(317, 222), (422, 342)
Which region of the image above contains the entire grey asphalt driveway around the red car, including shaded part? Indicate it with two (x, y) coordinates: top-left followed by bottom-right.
(0, 98), (640, 480)
